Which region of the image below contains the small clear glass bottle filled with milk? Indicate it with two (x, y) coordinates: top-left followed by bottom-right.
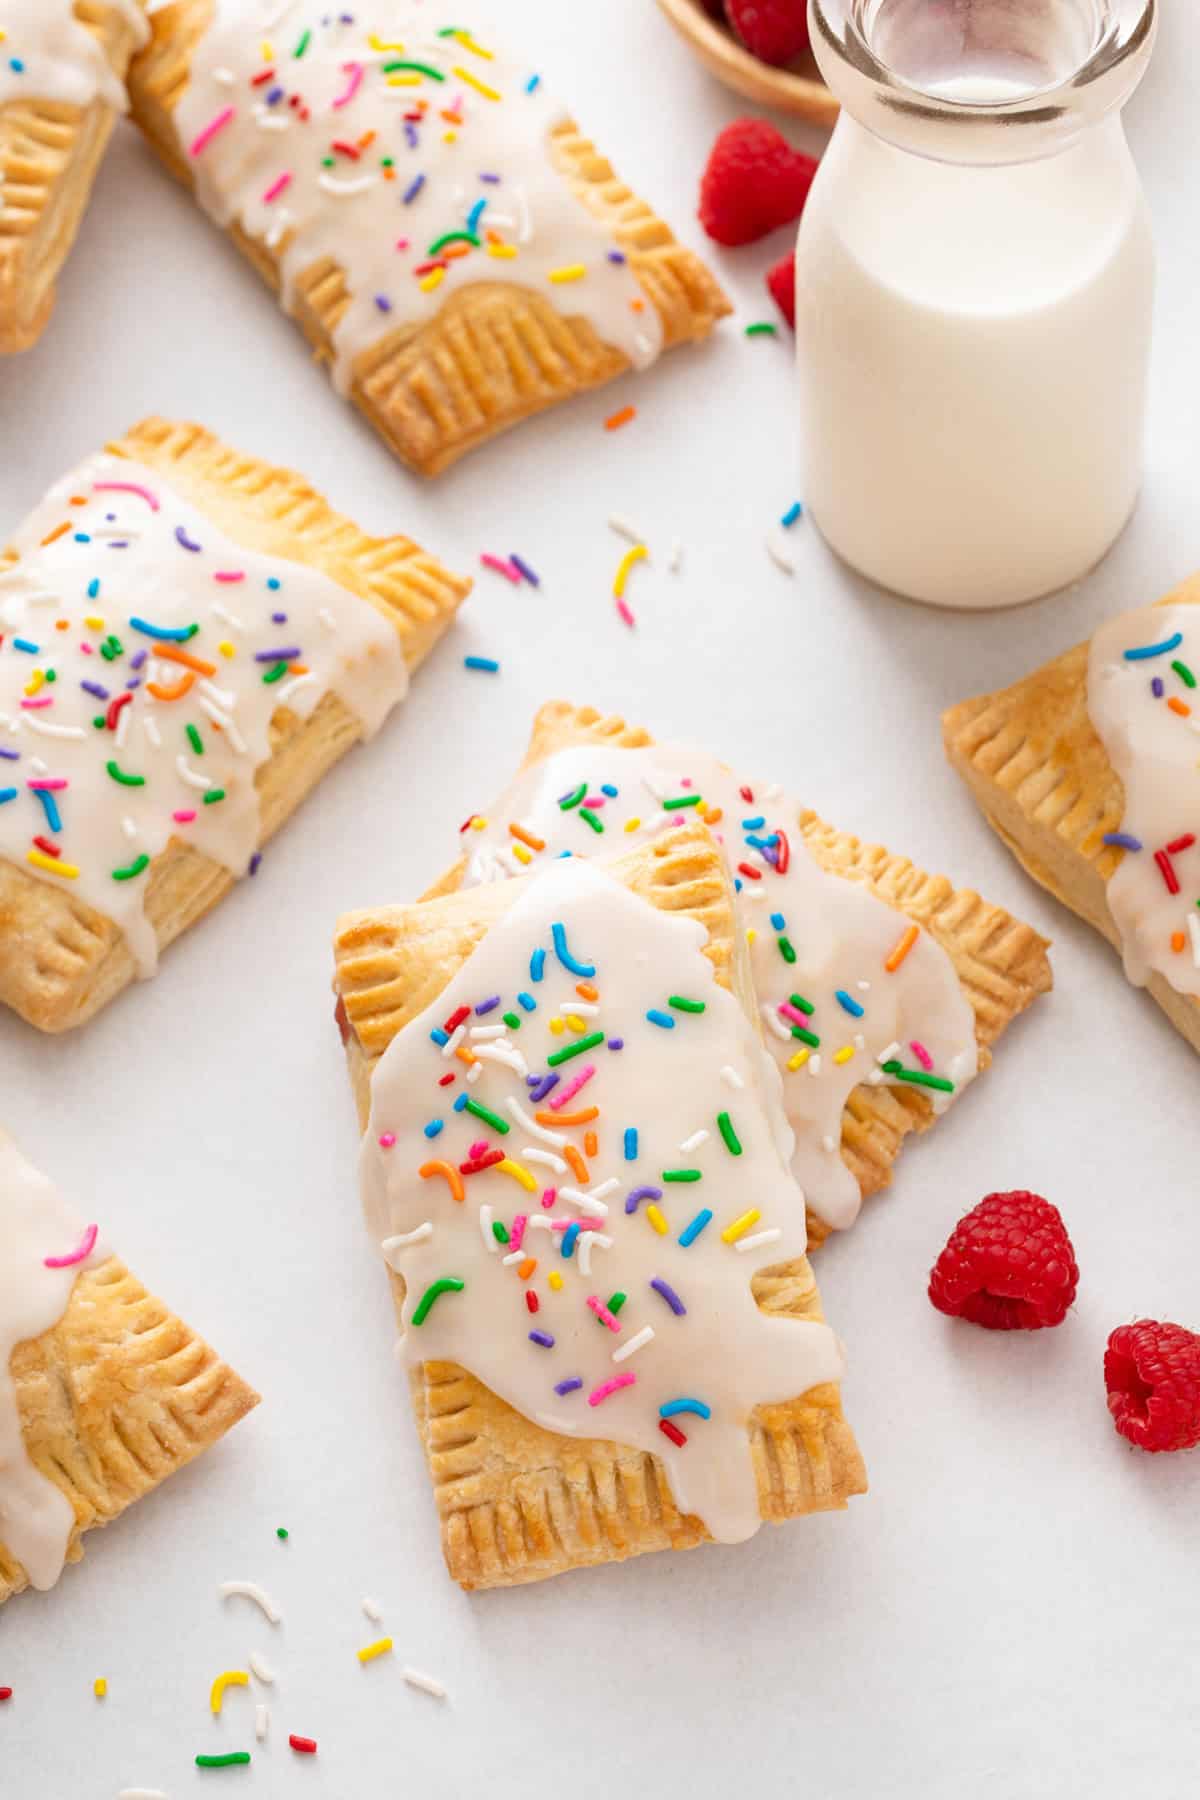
(795, 0), (1157, 607)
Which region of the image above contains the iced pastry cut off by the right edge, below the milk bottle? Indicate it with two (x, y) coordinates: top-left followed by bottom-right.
(943, 576), (1200, 1049)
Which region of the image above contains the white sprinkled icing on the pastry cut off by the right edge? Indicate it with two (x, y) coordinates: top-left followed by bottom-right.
(1087, 607), (1200, 995)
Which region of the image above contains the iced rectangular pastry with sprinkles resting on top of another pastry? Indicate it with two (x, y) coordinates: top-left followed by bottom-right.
(335, 821), (865, 1588)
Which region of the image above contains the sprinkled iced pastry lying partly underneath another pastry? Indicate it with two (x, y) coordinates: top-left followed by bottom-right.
(434, 702), (1051, 1244)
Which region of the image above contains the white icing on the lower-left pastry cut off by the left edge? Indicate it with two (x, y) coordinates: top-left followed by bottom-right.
(0, 1132), (108, 1588)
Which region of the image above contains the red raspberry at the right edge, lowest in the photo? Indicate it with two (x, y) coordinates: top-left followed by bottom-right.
(1105, 1319), (1200, 1451)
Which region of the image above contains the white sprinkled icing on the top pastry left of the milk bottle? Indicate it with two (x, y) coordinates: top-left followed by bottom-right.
(175, 0), (662, 392)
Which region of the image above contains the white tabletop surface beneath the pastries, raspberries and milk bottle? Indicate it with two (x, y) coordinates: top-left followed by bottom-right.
(0, 0), (1200, 1800)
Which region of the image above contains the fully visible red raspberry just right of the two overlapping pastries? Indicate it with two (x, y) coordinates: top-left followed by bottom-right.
(928, 1190), (1079, 1332)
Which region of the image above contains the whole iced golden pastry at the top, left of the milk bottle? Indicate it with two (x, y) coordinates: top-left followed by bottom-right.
(130, 0), (729, 475)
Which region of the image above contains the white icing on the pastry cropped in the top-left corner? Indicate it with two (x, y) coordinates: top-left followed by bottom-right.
(0, 0), (149, 112)
